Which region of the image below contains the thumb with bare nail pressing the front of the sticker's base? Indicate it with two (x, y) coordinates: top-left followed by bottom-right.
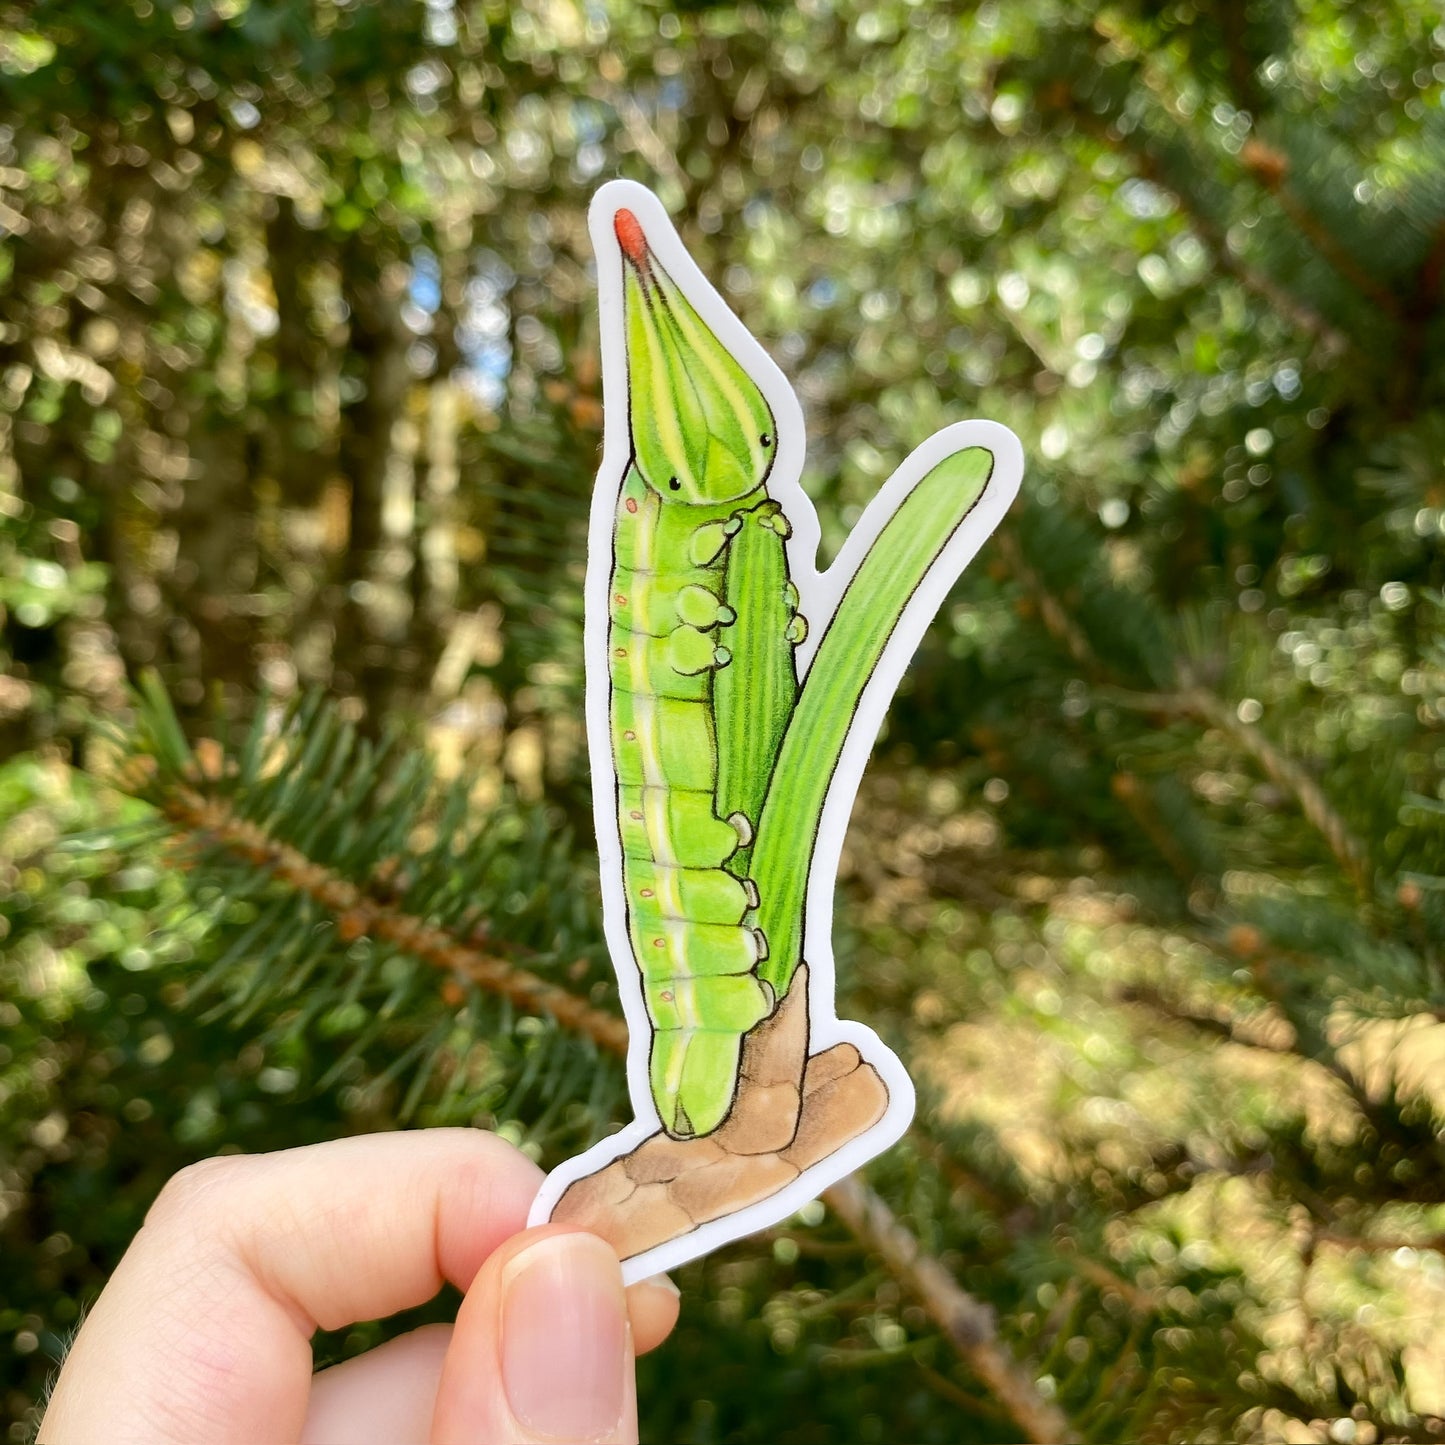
(432, 1224), (637, 1445)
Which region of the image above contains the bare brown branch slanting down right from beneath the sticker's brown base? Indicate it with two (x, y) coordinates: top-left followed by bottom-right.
(824, 1178), (1078, 1442)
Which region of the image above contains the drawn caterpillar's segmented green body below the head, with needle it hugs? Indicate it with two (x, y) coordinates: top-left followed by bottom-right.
(607, 467), (801, 1137)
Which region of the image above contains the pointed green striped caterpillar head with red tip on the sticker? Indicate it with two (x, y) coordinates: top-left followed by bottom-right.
(613, 211), (777, 504)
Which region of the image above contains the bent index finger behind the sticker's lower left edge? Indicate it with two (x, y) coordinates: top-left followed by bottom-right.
(40, 1129), (542, 1445)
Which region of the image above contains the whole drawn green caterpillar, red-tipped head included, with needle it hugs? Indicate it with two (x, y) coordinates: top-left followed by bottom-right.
(607, 210), (806, 1137)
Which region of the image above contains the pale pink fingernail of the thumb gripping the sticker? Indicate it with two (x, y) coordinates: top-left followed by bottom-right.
(501, 1234), (627, 1441)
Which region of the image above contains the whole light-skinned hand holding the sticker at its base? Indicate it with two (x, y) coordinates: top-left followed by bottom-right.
(39, 1129), (678, 1445)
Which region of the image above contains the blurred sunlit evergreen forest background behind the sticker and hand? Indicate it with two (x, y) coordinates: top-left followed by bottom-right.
(0, 0), (1445, 1445)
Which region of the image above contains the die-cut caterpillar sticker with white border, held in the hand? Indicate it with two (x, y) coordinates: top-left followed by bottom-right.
(530, 181), (1023, 1283)
